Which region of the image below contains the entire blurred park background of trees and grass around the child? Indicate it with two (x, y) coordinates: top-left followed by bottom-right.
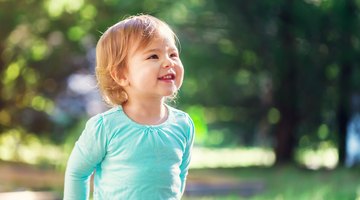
(0, 0), (360, 200)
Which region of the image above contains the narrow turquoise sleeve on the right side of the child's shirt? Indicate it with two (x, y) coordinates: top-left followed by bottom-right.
(180, 115), (195, 194)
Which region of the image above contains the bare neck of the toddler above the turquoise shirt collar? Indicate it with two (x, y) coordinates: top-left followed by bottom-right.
(122, 99), (168, 125)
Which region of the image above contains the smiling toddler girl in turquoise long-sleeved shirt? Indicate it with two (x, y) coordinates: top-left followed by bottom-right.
(64, 15), (194, 200)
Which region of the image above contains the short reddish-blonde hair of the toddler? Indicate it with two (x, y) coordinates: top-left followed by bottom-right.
(95, 15), (178, 105)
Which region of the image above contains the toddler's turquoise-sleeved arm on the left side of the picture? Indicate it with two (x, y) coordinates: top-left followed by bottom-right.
(64, 117), (106, 200)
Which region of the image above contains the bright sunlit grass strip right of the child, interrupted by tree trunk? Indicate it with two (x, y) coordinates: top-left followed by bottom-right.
(190, 147), (338, 170)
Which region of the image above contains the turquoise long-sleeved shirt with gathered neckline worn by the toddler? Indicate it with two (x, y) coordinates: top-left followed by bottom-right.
(64, 106), (194, 200)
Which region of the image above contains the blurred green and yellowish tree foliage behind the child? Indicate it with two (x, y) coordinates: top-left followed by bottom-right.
(0, 0), (360, 162)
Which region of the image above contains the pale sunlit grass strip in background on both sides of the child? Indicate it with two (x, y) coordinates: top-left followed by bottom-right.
(0, 129), (338, 169)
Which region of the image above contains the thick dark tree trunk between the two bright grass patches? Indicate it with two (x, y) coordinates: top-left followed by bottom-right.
(274, 0), (297, 164)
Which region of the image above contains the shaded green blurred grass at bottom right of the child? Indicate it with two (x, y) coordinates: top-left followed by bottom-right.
(183, 165), (360, 200)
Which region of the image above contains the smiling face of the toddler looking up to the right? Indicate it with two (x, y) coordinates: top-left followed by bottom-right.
(124, 35), (184, 100)
